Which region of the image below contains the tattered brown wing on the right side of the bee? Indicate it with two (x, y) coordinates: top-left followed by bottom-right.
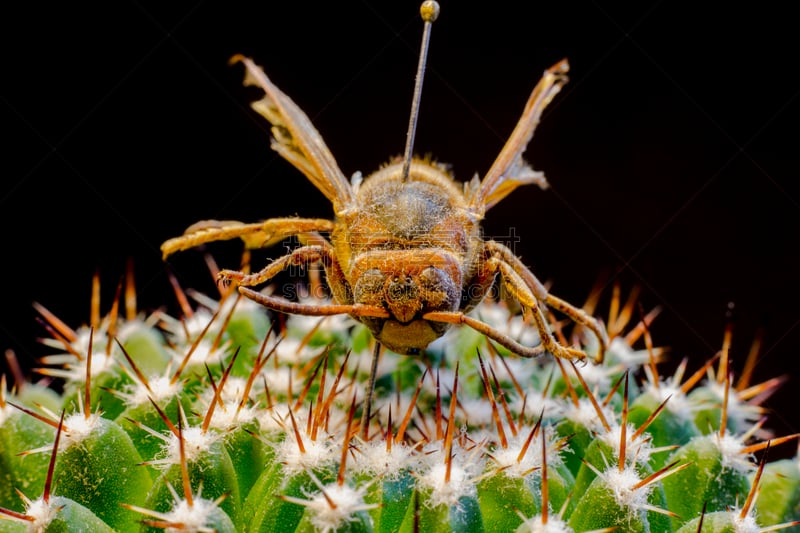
(470, 59), (569, 214)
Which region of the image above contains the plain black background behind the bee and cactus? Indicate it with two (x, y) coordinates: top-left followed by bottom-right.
(0, 0), (800, 453)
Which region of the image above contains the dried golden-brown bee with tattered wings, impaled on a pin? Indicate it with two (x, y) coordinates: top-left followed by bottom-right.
(161, 2), (608, 374)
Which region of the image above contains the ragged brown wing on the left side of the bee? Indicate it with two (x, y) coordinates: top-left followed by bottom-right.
(230, 54), (353, 213)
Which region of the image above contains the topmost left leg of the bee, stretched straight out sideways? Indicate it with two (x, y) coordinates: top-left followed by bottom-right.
(161, 218), (333, 259)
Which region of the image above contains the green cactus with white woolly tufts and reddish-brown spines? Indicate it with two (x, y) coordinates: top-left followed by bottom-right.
(0, 266), (800, 533)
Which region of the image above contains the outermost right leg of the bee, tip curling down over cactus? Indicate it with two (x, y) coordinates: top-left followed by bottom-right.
(486, 241), (608, 364)
